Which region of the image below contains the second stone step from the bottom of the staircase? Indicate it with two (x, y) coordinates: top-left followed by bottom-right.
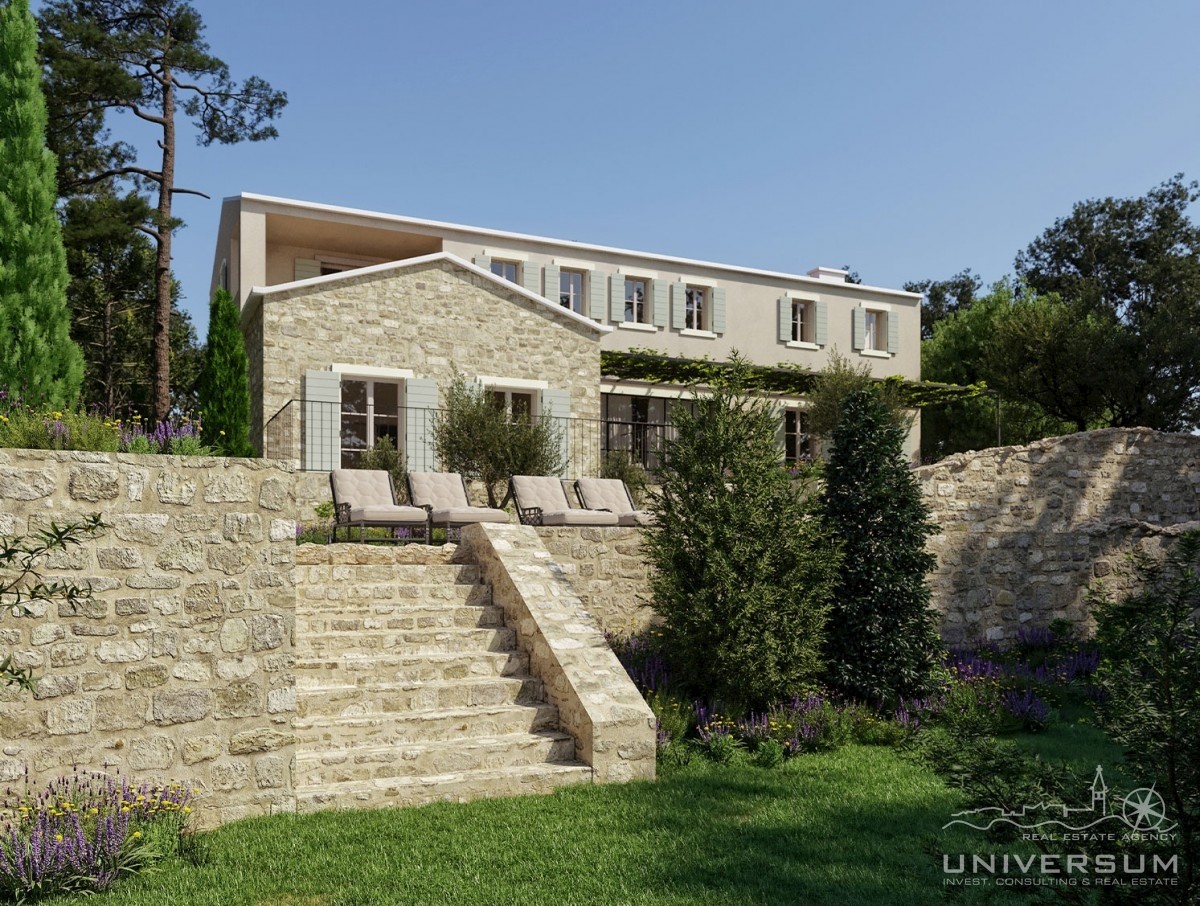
(294, 730), (575, 787)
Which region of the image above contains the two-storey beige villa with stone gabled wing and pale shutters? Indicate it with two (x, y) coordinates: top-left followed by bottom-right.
(212, 194), (920, 496)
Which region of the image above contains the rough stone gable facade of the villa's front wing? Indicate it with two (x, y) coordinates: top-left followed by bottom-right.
(249, 259), (606, 474)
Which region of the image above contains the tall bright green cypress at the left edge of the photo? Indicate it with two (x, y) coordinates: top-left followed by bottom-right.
(0, 0), (83, 408)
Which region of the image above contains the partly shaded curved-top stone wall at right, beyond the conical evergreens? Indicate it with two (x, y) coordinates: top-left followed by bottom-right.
(917, 428), (1200, 644)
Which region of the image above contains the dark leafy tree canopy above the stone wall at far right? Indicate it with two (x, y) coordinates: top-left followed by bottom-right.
(1007, 174), (1200, 431)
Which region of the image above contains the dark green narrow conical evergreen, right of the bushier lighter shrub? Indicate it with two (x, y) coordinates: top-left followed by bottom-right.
(822, 390), (942, 704)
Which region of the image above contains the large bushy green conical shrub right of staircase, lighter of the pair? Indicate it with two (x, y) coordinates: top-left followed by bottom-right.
(644, 359), (839, 708)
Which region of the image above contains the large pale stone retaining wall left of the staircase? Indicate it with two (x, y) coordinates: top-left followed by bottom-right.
(0, 450), (295, 826)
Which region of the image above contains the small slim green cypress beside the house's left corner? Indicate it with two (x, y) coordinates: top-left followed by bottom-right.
(199, 289), (254, 456)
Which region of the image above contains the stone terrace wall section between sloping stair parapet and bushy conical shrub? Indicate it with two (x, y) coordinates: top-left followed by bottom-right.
(535, 527), (653, 636)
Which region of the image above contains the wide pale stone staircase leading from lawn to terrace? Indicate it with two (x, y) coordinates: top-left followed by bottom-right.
(294, 545), (592, 811)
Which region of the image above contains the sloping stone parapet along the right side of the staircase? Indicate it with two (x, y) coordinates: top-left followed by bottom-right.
(460, 523), (655, 784)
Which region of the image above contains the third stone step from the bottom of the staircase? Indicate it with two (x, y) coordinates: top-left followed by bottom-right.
(293, 703), (558, 751)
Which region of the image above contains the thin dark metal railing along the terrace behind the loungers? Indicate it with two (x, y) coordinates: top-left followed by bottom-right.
(263, 400), (673, 479)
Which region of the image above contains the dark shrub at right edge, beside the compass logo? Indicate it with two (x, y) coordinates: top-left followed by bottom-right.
(1090, 532), (1200, 902)
